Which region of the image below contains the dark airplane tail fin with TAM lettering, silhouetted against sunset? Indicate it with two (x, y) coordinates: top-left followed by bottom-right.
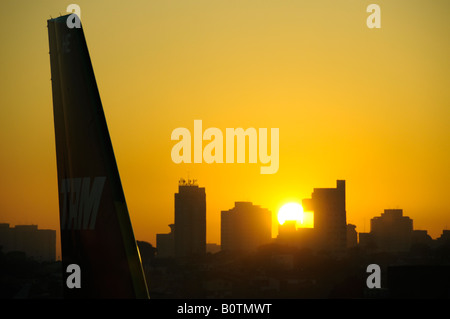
(47, 15), (148, 298)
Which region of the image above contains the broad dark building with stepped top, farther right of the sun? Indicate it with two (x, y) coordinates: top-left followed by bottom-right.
(370, 209), (413, 252)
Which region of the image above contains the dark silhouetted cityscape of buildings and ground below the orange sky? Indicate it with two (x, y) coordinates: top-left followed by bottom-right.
(0, 179), (450, 299)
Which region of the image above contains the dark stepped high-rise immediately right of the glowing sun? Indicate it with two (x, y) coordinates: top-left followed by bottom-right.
(302, 180), (347, 252)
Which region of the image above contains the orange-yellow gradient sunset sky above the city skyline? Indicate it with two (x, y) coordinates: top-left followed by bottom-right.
(0, 0), (450, 258)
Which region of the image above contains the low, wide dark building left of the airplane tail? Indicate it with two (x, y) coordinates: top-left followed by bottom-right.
(0, 224), (56, 261)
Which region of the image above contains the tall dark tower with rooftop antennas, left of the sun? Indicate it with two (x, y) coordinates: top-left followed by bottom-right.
(174, 180), (206, 257)
